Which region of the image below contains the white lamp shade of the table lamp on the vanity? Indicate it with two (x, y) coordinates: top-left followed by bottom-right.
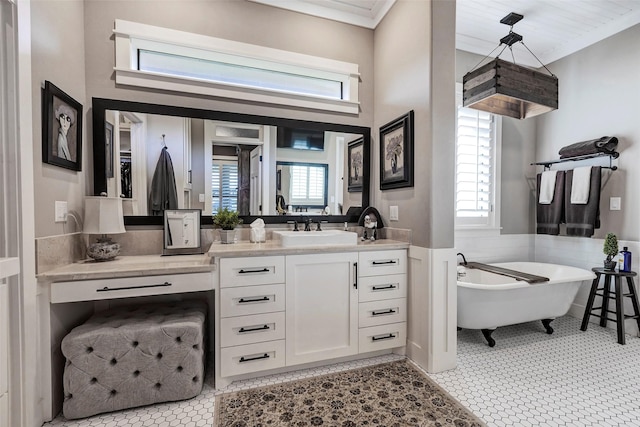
(83, 196), (126, 234)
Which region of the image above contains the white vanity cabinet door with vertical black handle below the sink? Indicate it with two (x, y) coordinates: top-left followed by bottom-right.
(286, 252), (358, 365)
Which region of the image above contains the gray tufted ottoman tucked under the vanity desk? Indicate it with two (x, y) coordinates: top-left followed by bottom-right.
(62, 301), (207, 419)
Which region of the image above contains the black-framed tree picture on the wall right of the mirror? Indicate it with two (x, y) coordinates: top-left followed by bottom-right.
(380, 110), (413, 190)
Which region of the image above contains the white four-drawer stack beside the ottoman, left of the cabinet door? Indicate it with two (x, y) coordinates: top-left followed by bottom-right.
(219, 256), (285, 377)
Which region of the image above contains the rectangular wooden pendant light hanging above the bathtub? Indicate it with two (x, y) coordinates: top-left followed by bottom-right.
(462, 12), (558, 119)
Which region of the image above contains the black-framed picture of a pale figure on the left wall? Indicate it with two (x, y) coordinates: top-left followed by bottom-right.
(42, 80), (82, 171)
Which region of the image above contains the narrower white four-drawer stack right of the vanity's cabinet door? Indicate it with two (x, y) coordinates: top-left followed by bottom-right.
(358, 249), (407, 353)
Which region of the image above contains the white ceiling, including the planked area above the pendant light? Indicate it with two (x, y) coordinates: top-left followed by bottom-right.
(251, 0), (640, 67)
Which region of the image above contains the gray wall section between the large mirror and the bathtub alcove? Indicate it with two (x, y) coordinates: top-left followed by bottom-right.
(372, 0), (455, 248)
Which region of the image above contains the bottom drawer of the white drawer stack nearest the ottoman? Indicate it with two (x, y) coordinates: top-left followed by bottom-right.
(220, 340), (285, 377)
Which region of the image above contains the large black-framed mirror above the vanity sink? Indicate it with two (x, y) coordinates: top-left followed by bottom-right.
(92, 98), (371, 225)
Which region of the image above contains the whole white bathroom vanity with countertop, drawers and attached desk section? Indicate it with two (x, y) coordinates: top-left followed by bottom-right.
(38, 240), (409, 419)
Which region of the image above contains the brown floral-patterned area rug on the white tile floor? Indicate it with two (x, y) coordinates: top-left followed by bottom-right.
(214, 360), (484, 427)
